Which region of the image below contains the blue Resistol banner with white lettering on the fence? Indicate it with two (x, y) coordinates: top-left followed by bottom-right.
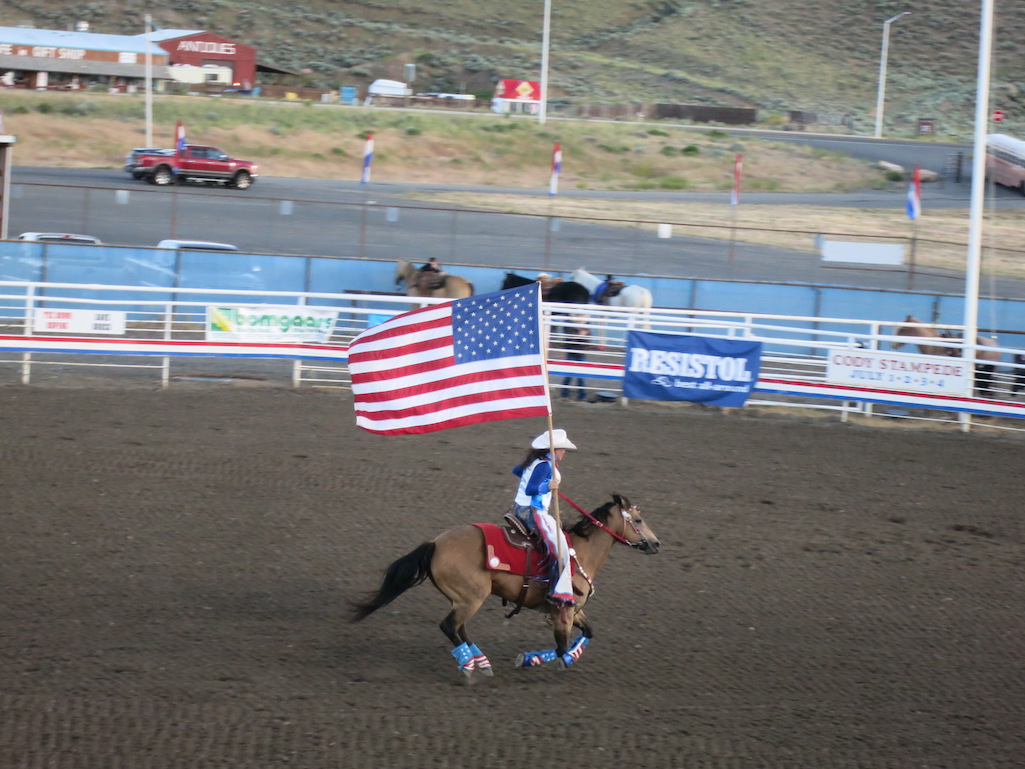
(623, 331), (762, 407)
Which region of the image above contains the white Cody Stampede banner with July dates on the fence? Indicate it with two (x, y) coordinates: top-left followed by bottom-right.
(826, 350), (973, 395)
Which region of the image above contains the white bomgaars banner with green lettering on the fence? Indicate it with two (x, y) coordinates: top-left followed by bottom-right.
(206, 305), (338, 343)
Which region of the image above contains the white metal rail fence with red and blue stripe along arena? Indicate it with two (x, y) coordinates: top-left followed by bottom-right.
(0, 281), (1025, 430)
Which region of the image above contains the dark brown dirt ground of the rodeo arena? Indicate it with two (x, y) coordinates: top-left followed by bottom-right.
(0, 382), (1025, 769)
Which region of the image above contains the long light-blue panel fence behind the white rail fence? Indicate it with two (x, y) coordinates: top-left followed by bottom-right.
(0, 241), (1025, 348)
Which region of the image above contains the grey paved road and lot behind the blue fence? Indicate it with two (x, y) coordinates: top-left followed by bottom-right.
(9, 167), (1025, 296)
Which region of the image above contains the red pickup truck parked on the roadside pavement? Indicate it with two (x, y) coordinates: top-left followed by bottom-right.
(125, 145), (258, 190)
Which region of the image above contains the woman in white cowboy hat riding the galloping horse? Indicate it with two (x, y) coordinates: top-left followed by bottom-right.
(513, 430), (576, 606)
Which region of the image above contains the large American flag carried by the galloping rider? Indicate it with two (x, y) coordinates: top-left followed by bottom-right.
(349, 283), (551, 435)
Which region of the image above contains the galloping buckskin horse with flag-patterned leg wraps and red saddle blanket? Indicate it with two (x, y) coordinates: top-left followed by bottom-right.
(351, 493), (660, 678)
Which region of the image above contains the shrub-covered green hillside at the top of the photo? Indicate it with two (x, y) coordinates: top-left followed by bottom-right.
(6, 0), (1025, 136)
